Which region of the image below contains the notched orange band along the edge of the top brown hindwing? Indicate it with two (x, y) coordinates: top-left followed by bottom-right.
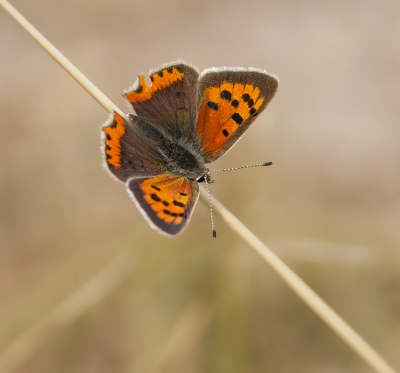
(125, 67), (185, 103)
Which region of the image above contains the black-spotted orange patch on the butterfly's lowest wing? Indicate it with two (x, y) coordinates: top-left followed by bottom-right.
(140, 174), (192, 224)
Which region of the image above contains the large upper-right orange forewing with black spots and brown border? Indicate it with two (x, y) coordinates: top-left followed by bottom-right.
(196, 68), (278, 163)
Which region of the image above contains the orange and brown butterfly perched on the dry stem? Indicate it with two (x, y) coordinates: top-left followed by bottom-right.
(102, 61), (278, 237)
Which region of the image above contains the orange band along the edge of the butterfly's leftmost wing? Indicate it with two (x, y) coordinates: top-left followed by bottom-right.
(103, 113), (125, 168)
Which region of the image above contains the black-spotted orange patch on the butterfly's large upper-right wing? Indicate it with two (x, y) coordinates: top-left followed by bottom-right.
(196, 82), (264, 152)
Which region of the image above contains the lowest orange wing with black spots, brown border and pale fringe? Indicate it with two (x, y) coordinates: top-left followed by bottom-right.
(126, 173), (199, 236)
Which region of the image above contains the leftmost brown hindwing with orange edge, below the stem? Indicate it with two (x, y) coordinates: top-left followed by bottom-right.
(101, 113), (165, 182)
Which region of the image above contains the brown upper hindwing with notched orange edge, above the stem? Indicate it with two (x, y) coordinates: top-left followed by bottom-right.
(125, 61), (199, 139)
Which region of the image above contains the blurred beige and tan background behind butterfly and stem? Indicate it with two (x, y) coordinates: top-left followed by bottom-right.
(0, 0), (400, 373)
